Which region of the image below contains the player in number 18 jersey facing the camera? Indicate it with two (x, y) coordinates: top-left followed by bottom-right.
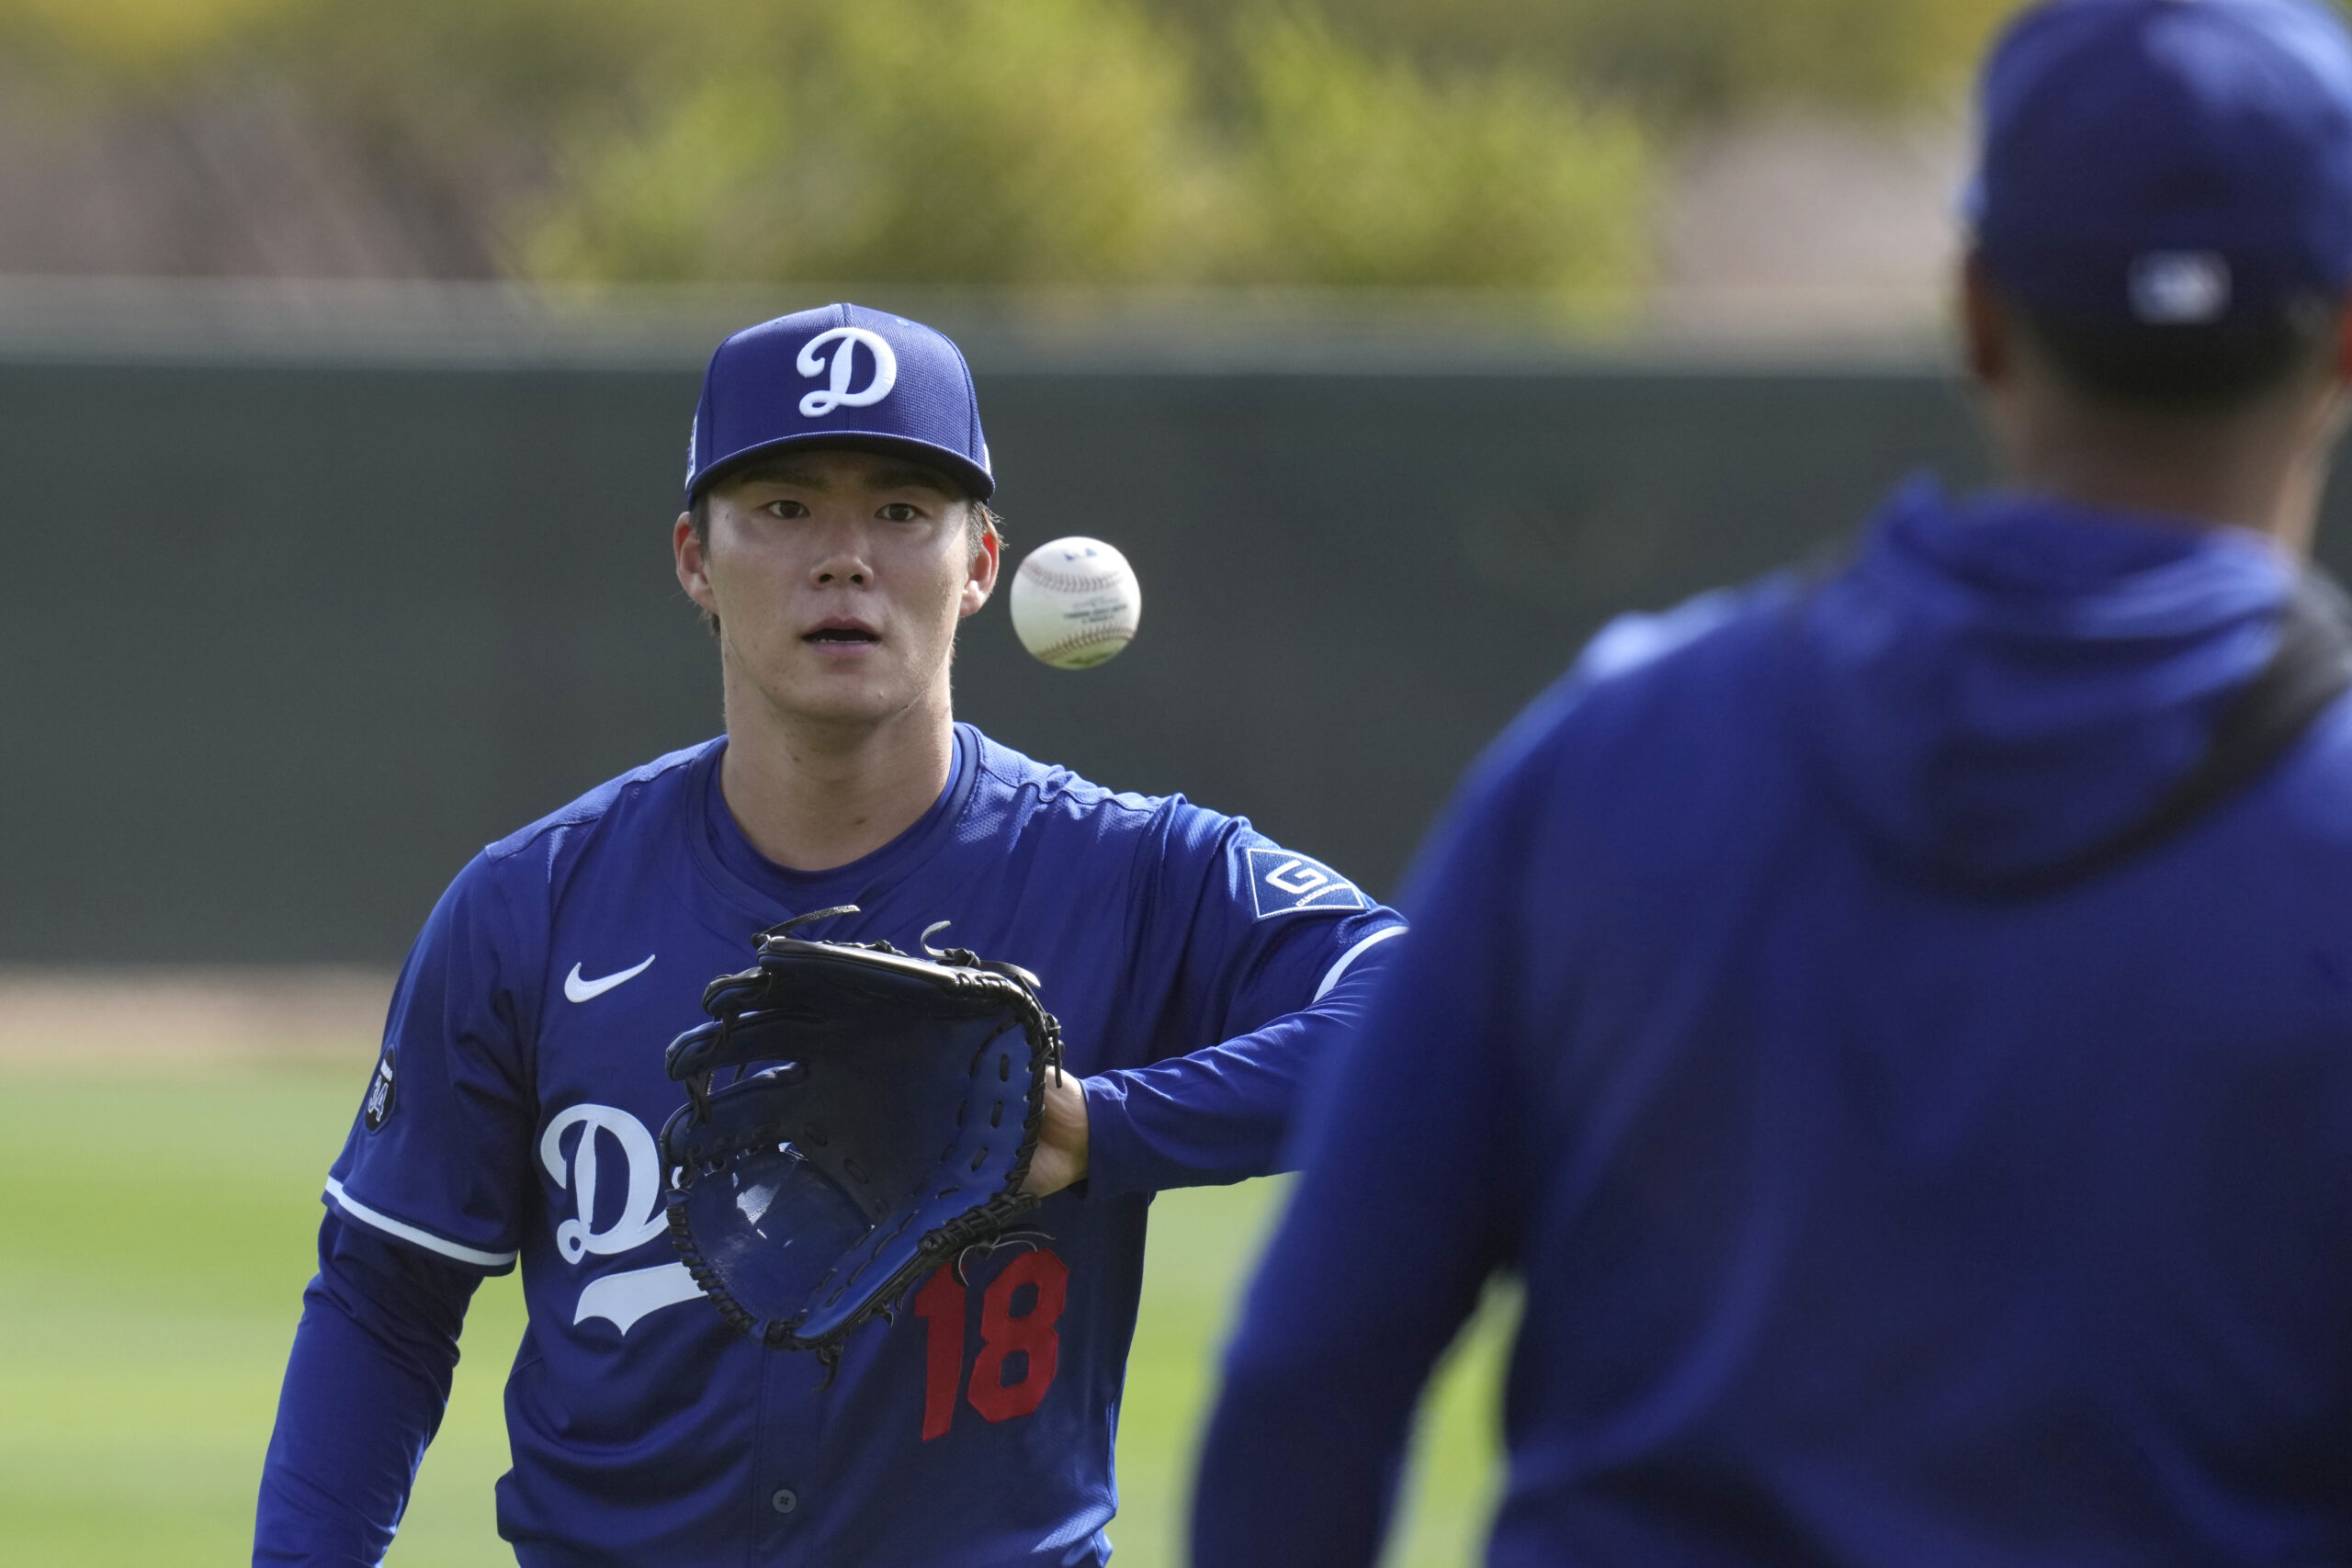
(254, 306), (1402, 1568)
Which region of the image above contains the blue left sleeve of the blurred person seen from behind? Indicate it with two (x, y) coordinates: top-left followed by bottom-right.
(1193, 747), (1529, 1568)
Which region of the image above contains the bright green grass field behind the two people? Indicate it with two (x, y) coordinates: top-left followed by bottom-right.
(0, 1063), (1508, 1568)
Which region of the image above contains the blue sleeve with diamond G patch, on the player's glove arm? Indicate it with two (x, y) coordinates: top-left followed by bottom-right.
(1087, 807), (1404, 1192)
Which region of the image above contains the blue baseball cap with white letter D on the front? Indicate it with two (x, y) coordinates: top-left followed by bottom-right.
(687, 306), (997, 505)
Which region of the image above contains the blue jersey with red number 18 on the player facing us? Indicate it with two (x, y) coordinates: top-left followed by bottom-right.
(327, 727), (1402, 1568)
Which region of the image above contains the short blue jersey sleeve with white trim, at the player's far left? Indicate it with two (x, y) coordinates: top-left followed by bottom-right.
(327, 856), (546, 1274)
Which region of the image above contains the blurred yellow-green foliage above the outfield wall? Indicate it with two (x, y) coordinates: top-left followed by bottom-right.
(0, 0), (2013, 310)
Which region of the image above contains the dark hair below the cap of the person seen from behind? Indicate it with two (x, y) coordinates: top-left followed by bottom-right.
(2023, 301), (2335, 413)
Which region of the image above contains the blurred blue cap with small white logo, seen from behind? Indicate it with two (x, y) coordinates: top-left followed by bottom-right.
(1966, 0), (2352, 327)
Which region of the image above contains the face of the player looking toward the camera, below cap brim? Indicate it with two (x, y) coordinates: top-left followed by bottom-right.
(673, 451), (997, 727)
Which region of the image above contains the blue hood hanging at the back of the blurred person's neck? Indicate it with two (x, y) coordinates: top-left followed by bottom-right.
(1799, 479), (2296, 884)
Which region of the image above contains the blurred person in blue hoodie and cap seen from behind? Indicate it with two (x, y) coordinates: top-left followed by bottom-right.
(1193, 0), (2352, 1568)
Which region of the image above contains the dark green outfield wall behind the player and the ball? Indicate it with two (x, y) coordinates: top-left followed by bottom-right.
(0, 362), (2060, 964)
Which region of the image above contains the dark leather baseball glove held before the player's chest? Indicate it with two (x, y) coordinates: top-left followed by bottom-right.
(661, 905), (1061, 1378)
